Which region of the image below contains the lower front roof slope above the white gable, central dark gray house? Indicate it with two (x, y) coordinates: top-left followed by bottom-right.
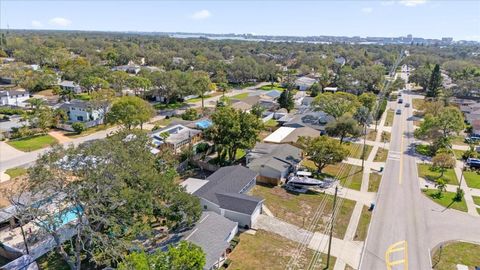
(216, 193), (263, 215)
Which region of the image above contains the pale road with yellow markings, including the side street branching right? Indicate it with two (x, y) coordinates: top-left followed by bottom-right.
(360, 77), (480, 269)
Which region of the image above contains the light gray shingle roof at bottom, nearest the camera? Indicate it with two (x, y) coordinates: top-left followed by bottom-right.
(184, 211), (238, 269)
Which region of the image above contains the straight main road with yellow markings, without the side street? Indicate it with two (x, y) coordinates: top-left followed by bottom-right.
(360, 86), (431, 270)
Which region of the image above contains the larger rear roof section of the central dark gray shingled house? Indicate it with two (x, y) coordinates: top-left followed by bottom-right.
(193, 165), (258, 205)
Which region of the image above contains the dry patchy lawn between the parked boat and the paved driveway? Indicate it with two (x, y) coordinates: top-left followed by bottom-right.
(252, 185), (355, 239)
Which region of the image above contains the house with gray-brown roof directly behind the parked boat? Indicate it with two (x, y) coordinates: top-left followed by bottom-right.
(246, 143), (302, 185)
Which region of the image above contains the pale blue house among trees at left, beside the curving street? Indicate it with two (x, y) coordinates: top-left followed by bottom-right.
(60, 99), (106, 127)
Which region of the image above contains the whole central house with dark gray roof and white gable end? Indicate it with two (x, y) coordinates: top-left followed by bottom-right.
(193, 165), (264, 228)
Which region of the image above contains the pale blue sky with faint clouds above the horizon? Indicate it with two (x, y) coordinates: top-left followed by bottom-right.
(0, 0), (480, 41)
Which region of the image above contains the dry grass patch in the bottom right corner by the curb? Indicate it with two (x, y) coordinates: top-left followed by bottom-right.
(432, 242), (480, 270)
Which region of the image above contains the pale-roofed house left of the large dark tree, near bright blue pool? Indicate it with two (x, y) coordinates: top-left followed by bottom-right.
(151, 124), (202, 153)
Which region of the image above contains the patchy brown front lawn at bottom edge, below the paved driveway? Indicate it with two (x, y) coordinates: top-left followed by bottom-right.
(228, 230), (335, 270)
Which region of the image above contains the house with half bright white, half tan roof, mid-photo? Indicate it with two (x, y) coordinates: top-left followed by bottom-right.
(263, 126), (320, 144)
